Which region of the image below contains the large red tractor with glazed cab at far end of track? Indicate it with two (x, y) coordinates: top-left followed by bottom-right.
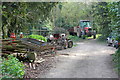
(68, 20), (96, 39)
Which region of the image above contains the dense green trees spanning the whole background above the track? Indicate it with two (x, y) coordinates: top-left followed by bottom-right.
(1, 1), (120, 77)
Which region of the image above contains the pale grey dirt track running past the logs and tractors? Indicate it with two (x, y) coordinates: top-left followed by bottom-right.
(39, 40), (118, 78)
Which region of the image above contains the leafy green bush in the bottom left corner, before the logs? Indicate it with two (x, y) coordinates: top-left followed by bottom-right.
(0, 55), (25, 78)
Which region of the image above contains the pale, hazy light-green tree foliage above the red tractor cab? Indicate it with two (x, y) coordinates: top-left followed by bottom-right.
(52, 2), (90, 29)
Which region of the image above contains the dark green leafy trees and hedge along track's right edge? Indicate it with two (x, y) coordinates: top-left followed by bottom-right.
(91, 1), (120, 73)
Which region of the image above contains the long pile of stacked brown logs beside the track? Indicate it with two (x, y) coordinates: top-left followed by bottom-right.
(2, 39), (54, 61)
